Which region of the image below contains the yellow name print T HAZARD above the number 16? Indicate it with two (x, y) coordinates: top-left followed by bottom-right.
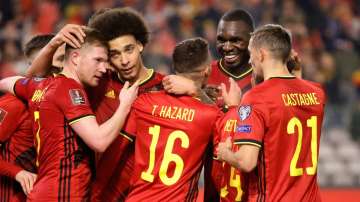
(151, 105), (195, 122)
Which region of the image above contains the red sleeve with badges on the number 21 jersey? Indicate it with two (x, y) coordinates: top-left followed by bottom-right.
(233, 94), (266, 147)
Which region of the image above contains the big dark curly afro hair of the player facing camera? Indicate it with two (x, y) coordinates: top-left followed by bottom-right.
(88, 8), (149, 46)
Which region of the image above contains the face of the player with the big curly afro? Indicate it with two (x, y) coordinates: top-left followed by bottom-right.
(109, 35), (144, 81)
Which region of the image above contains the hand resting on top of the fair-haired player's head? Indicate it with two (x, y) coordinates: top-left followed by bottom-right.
(49, 24), (86, 48)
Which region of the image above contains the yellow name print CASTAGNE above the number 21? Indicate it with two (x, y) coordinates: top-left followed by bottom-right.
(281, 93), (320, 106)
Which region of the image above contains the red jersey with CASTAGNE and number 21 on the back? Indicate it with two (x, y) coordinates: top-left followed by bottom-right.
(234, 77), (325, 201)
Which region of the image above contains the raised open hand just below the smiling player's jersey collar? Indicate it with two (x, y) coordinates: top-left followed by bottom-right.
(221, 78), (242, 106)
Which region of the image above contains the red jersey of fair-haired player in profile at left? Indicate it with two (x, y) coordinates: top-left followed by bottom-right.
(14, 75), (93, 201)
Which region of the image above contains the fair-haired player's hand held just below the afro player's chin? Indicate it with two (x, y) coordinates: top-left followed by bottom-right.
(119, 80), (140, 107)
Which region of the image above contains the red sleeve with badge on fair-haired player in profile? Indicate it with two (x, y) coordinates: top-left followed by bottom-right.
(55, 80), (94, 124)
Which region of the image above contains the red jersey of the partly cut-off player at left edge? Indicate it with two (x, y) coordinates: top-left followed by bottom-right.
(0, 94), (36, 202)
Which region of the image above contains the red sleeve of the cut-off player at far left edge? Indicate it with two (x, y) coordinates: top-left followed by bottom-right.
(0, 94), (26, 142)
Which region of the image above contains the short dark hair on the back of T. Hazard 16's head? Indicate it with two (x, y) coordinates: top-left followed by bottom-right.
(172, 37), (210, 73)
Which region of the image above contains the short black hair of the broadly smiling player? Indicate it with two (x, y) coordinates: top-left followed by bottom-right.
(221, 8), (255, 31)
